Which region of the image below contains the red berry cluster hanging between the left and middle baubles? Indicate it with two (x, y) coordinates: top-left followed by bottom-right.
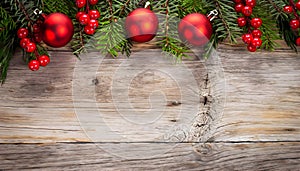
(76, 0), (100, 35)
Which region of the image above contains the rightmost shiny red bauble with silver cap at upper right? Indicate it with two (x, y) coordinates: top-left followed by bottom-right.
(178, 13), (213, 46)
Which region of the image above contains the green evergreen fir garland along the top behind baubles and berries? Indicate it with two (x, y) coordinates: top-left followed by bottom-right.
(0, 0), (299, 83)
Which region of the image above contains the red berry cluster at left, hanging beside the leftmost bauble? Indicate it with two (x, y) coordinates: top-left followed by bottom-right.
(17, 25), (50, 71)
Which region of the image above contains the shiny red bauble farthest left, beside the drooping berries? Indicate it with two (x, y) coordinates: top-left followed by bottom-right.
(41, 13), (74, 48)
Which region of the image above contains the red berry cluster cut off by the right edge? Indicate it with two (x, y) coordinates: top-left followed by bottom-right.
(283, 0), (300, 46)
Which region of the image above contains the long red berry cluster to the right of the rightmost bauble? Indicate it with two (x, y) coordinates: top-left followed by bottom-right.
(234, 0), (262, 52)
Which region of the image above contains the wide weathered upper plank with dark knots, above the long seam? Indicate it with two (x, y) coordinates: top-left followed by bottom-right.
(0, 46), (300, 143)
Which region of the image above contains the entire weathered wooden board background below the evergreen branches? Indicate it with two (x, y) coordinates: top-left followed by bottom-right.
(0, 45), (300, 170)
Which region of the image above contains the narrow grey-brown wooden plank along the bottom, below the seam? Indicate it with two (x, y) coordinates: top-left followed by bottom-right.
(0, 142), (300, 170)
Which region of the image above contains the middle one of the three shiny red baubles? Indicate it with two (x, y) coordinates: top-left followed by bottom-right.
(125, 8), (158, 43)
